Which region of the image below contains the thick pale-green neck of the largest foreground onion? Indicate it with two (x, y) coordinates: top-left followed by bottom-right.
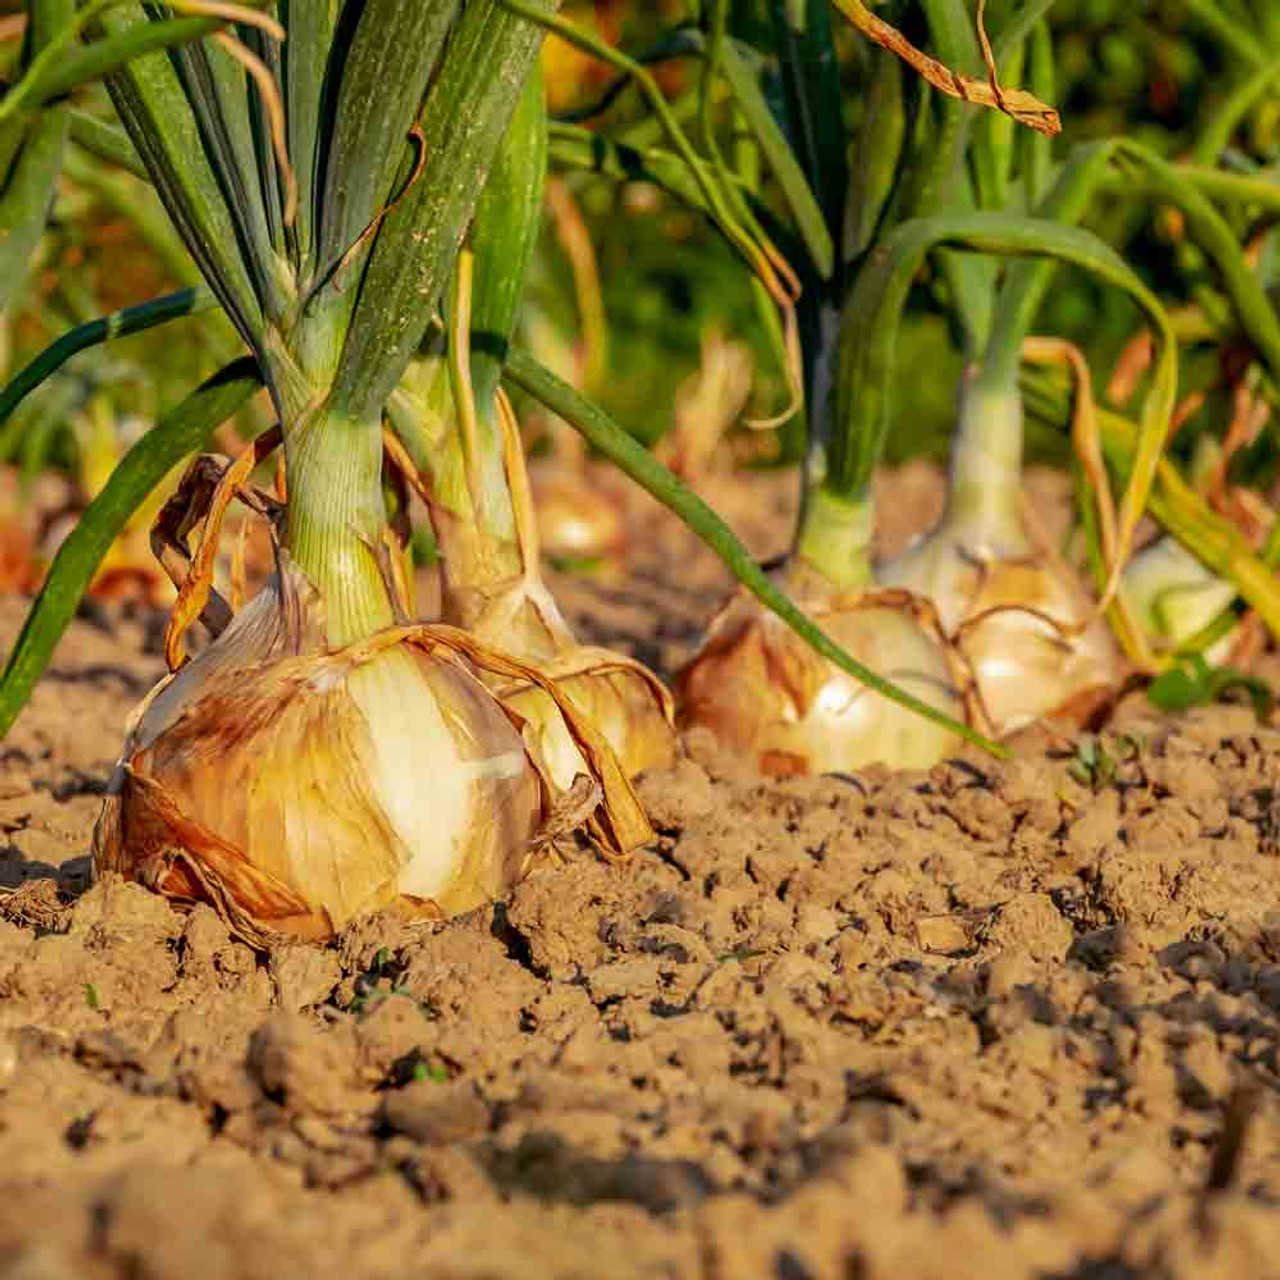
(284, 406), (394, 648)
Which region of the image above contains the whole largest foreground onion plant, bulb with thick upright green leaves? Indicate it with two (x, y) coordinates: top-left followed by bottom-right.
(19, 0), (670, 941)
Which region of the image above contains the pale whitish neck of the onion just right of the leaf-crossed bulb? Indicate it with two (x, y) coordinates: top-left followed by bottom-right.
(942, 367), (1025, 549)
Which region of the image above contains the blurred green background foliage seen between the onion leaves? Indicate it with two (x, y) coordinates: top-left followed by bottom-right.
(0, 0), (1280, 586)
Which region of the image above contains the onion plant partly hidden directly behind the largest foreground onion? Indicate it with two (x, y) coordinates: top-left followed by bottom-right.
(388, 67), (676, 787)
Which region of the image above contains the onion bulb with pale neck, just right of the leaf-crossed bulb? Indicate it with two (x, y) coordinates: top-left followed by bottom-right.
(878, 385), (1119, 736)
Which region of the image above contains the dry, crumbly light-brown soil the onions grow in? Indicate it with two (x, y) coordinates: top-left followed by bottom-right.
(0, 470), (1280, 1280)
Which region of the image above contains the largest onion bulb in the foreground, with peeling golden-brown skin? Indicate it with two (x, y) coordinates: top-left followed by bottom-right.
(93, 535), (648, 945)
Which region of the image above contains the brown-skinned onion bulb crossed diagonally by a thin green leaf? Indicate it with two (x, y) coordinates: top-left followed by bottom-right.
(676, 594), (964, 776)
